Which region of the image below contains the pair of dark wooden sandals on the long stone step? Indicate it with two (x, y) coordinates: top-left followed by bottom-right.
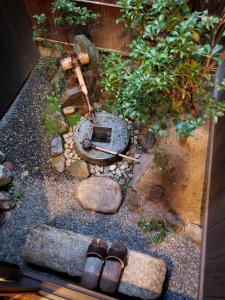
(81, 239), (127, 293)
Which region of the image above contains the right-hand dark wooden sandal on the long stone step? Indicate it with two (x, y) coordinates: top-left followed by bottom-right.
(100, 243), (127, 293)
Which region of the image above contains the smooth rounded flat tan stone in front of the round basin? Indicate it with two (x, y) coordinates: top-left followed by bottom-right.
(76, 176), (122, 213)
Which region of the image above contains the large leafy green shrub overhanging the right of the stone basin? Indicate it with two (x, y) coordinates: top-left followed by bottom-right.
(101, 0), (225, 137)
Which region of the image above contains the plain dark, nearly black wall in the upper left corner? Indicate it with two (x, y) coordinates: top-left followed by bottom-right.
(0, 0), (38, 118)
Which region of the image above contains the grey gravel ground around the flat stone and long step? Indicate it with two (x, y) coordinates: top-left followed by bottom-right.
(0, 66), (200, 300)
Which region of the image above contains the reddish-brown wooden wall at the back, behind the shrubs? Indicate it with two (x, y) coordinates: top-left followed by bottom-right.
(24, 0), (130, 52)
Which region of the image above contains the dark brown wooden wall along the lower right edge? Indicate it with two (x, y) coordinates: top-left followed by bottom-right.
(198, 117), (225, 300)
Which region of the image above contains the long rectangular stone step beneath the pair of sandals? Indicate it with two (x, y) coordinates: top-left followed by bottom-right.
(23, 225), (167, 300)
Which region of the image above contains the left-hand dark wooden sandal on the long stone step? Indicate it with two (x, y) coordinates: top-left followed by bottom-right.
(81, 239), (107, 290)
